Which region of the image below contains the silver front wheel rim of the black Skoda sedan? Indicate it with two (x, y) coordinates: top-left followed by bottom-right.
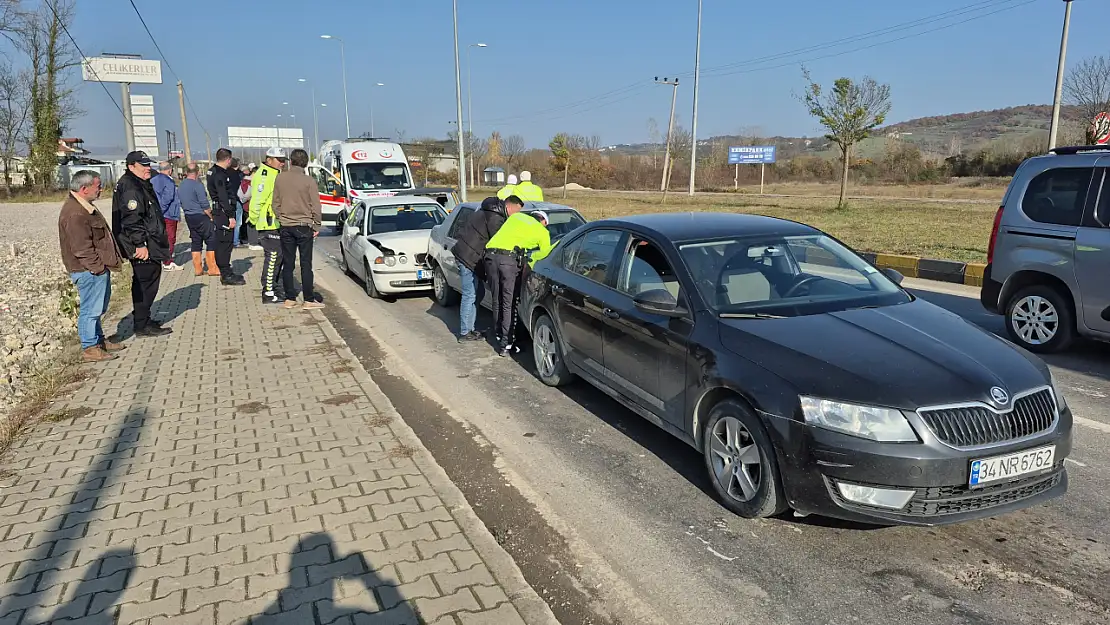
(709, 416), (764, 503)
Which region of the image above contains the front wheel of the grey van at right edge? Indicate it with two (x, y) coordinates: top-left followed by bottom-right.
(1006, 284), (1076, 354)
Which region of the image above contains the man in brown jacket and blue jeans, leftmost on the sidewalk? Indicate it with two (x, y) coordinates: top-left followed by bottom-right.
(58, 170), (124, 362)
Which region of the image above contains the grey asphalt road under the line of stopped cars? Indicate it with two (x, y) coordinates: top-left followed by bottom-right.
(308, 236), (1110, 625)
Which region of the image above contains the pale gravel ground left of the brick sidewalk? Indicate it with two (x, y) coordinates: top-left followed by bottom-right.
(0, 200), (79, 415)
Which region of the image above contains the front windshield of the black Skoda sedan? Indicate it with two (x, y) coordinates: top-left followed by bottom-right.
(679, 234), (911, 316)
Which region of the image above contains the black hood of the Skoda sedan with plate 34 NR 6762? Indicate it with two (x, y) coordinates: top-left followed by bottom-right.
(720, 300), (1048, 410)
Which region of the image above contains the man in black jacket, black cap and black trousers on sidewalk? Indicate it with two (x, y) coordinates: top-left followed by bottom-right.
(112, 151), (173, 336)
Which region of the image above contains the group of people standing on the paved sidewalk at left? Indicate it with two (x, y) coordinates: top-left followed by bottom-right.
(58, 148), (323, 362)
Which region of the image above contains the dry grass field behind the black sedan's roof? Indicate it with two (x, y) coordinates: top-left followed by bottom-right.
(559, 191), (1001, 262)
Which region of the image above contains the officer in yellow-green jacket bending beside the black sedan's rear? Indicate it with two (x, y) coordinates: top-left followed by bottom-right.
(485, 195), (552, 356)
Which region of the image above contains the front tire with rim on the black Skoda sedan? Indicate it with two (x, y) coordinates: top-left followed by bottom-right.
(703, 400), (788, 518)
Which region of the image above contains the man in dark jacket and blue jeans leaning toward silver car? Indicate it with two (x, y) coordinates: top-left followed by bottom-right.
(451, 198), (508, 342)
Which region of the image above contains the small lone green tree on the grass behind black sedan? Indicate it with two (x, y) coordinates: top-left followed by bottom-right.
(801, 69), (890, 206)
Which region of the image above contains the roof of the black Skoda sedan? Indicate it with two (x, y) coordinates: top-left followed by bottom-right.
(591, 212), (821, 243)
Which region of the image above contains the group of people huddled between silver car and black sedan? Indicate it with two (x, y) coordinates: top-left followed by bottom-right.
(451, 190), (552, 356)
